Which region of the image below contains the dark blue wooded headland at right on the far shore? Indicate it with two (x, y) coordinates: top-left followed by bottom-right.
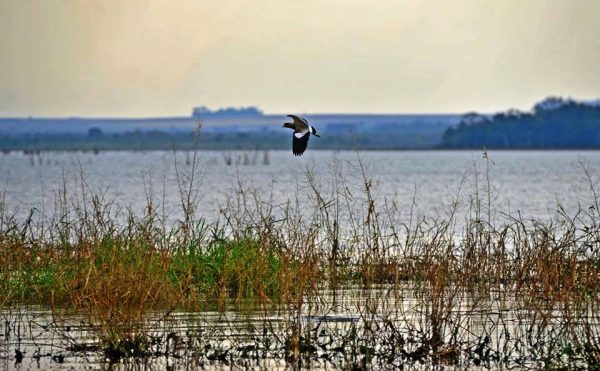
(439, 97), (600, 149)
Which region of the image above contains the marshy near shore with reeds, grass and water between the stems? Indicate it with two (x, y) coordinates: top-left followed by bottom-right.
(0, 153), (600, 368)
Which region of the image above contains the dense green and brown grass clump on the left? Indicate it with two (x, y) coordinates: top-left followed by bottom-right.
(0, 225), (297, 312)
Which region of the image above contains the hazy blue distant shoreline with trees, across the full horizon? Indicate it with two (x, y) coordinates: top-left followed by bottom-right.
(0, 97), (600, 153)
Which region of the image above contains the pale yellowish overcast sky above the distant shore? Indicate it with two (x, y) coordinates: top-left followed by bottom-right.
(0, 0), (600, 117)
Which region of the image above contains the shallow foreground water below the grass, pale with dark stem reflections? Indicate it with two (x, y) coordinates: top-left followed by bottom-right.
(0, 285), (600, 369)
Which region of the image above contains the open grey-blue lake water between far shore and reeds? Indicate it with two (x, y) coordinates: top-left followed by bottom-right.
(0, 151), (600, 227)
